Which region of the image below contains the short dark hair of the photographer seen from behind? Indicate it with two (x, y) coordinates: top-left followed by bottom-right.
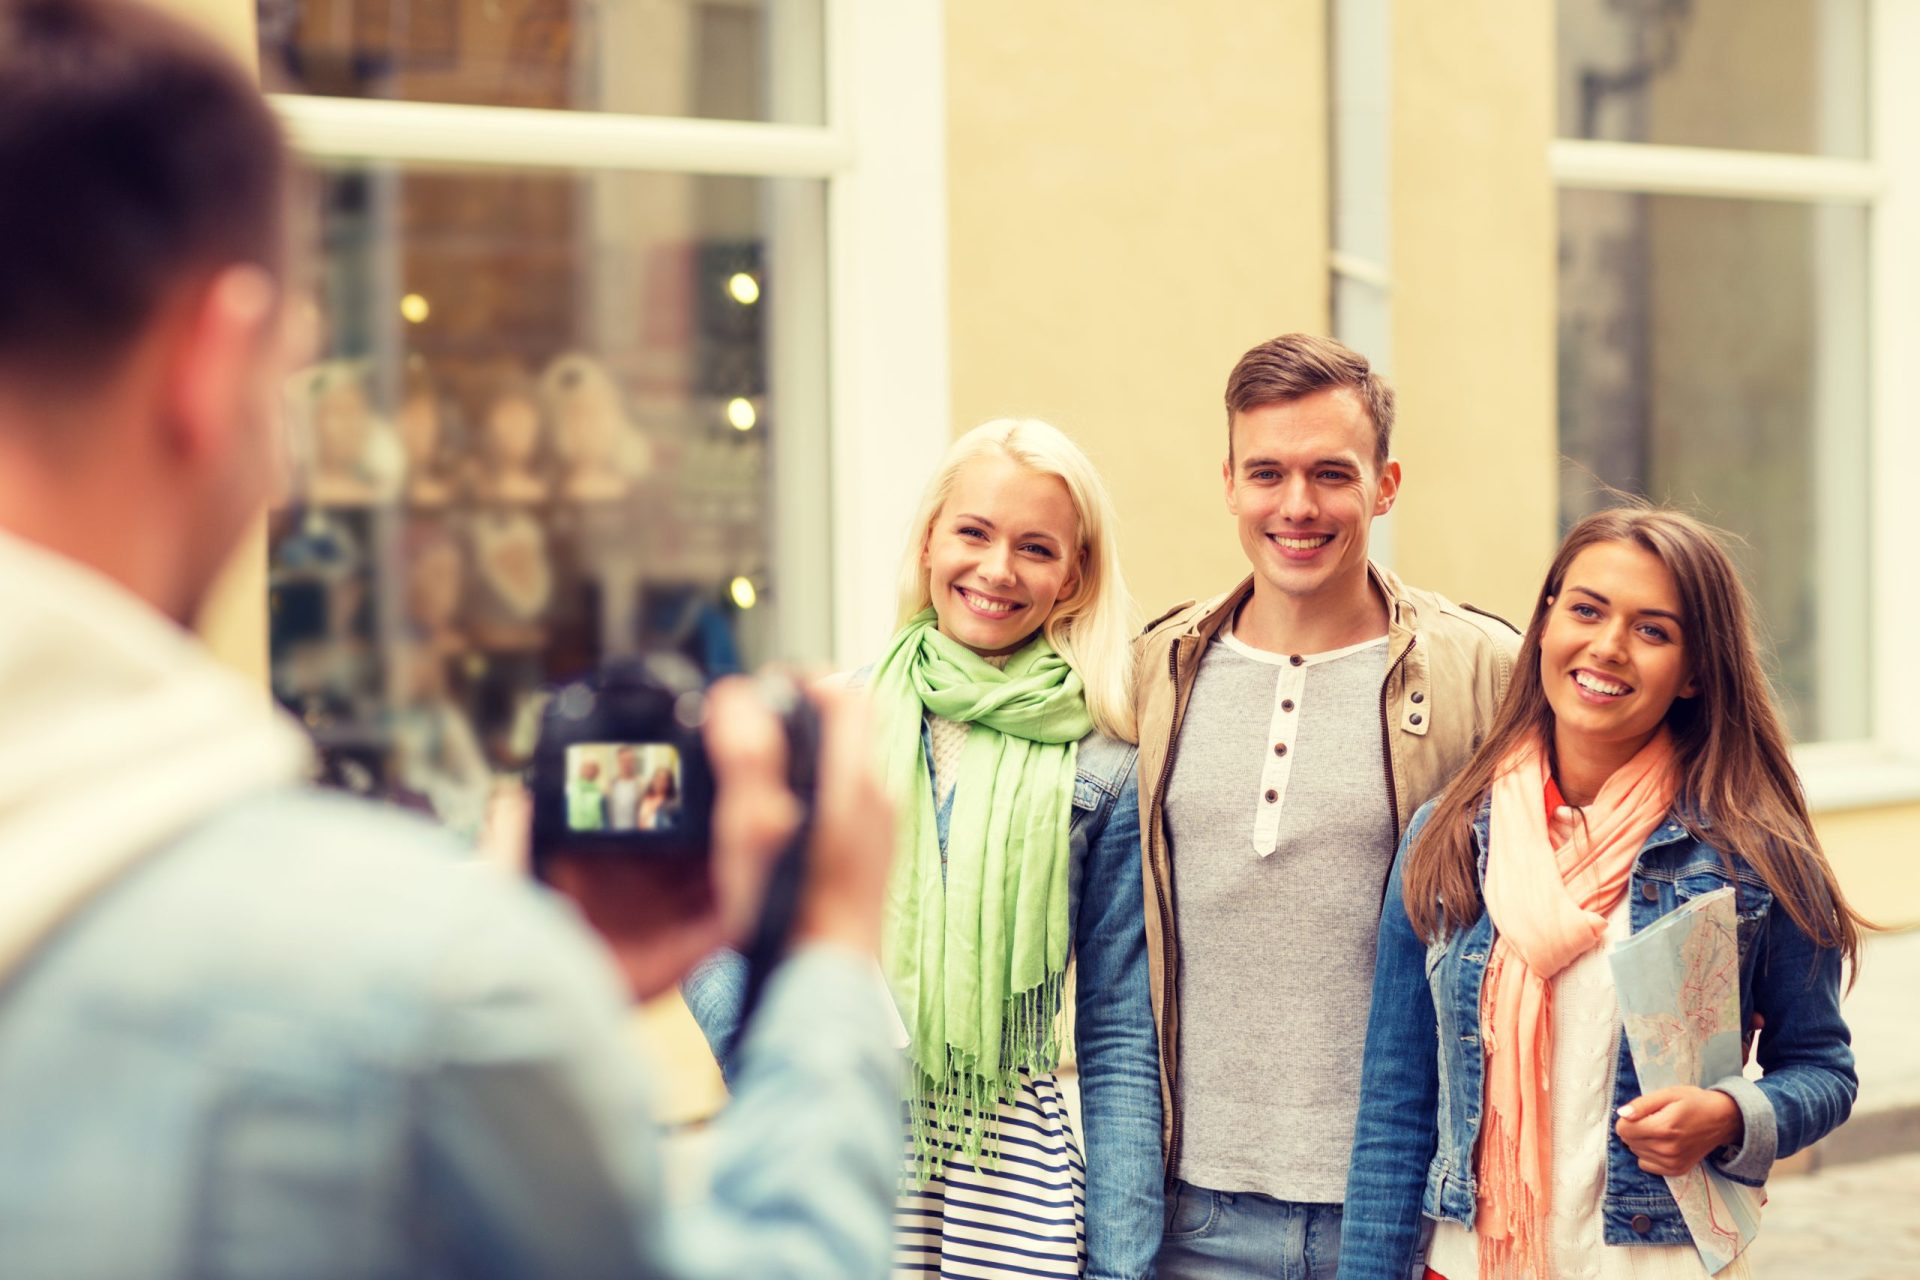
(0, 0), (288, 382)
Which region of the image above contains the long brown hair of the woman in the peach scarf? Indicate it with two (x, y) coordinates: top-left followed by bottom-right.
(1404, 507), (1872, 969)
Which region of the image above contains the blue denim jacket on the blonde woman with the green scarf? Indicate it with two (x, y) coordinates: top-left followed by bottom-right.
(684, 733), (1165, 1280)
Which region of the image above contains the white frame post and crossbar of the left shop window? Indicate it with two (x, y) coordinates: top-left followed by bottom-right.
(271, 0), (952, 666)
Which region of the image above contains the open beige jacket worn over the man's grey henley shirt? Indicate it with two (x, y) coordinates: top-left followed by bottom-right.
(1133, 566), (1521, 1176)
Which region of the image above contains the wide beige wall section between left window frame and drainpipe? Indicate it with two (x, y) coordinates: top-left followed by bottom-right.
(947, 0), (1329, 616)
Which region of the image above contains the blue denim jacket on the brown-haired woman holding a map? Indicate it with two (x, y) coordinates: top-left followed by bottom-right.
(1340, 802), (1859, 1280)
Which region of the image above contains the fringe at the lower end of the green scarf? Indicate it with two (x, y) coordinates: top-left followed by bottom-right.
(904, 967), (1066, 1188)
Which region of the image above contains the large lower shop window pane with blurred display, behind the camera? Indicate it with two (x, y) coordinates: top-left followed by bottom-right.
(269, 165), (828, 833)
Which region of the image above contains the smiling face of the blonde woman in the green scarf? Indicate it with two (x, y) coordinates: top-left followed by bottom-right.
(922, 453), (1081, 654)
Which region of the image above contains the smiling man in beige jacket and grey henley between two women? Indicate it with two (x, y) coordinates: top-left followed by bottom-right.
(1135, 334), (1519, 1280)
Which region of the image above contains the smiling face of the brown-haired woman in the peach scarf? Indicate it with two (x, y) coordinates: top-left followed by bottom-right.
(1540, 541), (1693, 754)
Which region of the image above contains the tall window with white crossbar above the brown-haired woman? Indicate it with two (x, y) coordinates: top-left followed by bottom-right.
(1553, 0), (1884, 743)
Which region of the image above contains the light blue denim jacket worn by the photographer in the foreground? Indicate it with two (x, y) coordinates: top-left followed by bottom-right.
(0, 791), (900, 1280)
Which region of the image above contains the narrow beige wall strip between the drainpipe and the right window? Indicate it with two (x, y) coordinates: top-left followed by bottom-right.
(1390, 0), (1559, 626)
